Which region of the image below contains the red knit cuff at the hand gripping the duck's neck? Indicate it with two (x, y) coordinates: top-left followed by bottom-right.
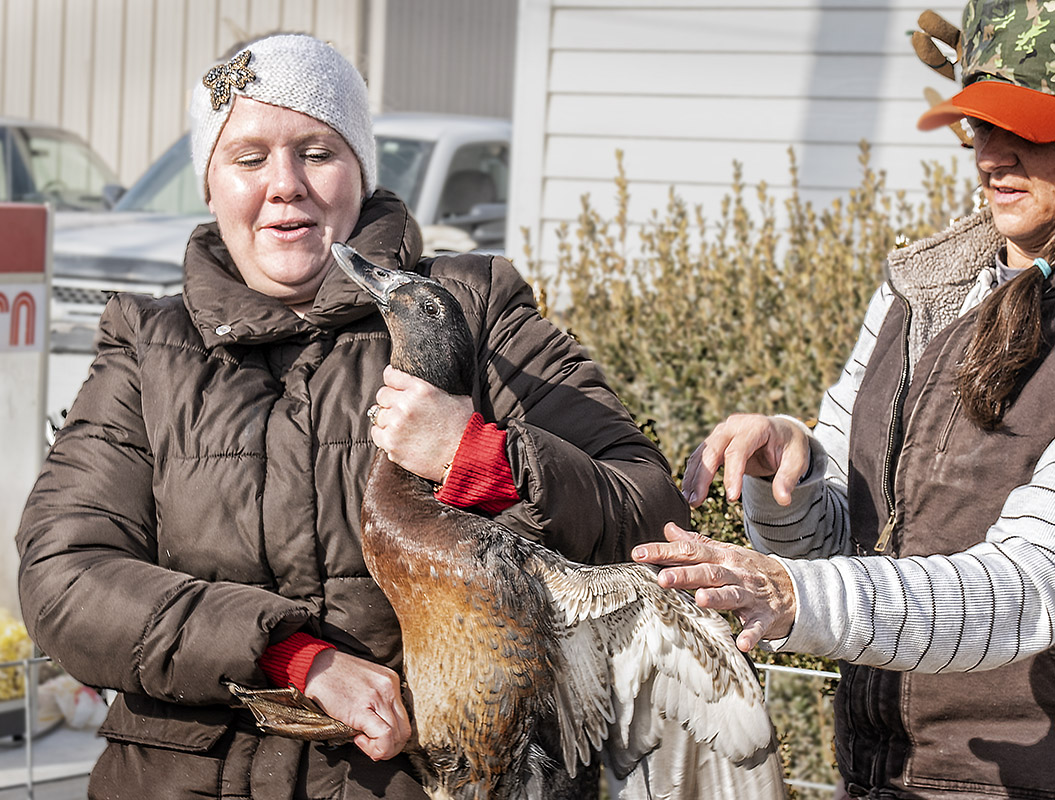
(436, 414), (520, 514)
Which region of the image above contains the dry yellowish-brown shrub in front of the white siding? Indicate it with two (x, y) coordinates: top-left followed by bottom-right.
(525, 144), (976, 798)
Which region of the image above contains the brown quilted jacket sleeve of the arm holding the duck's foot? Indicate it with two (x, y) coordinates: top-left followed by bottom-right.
(17, 300), (308, 703)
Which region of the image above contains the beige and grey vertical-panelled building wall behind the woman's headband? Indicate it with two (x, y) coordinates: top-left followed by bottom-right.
(0, 0), (517, 185)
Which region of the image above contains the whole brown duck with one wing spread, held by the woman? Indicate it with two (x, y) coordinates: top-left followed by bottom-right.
(231, 244), (786, 800)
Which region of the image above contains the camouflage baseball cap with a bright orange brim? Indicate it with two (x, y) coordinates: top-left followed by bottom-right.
(918, 0), (1055, 142)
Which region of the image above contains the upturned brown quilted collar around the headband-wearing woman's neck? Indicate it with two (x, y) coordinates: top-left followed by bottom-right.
(184, 189), (422, 348)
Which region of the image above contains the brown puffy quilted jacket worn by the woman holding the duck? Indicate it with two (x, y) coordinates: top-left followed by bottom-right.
(18, 192), (687, 799)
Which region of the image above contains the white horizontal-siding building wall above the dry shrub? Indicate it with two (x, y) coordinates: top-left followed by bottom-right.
(509, 0), (973, 272)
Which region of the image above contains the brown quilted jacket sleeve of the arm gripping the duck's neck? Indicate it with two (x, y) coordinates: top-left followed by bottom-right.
(440, 258), (688, 563)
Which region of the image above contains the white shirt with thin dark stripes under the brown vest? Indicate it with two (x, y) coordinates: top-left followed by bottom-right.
(744, 284), (1055, 672)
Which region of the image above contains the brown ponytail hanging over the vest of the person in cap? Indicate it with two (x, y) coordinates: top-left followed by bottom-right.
(957, 258), (1051, 431)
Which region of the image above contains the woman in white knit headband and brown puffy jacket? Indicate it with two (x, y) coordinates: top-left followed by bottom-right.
(18, 35), (688, 800)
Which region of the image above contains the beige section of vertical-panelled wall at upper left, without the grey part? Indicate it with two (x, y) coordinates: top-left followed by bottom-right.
(0, 0), (365, 184)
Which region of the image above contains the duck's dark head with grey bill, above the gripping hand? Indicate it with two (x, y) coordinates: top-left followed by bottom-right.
(330, 243), (475, 395)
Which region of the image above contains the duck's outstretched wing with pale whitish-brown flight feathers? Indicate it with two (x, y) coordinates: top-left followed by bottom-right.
(527, 552), (785, 800)
